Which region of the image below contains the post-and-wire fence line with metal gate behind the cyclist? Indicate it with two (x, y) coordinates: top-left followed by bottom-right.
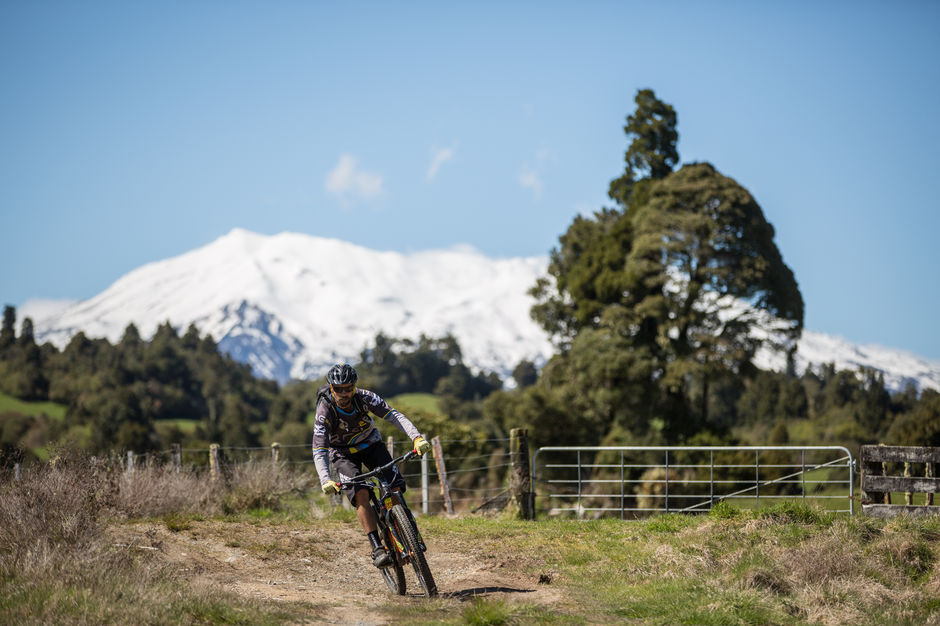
(16, 438), (872, 519)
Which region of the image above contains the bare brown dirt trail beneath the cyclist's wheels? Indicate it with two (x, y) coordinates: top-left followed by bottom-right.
(113, 521), (561, 624)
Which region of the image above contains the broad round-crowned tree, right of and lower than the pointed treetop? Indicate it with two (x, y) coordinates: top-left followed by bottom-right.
(627, 163), (803, 418)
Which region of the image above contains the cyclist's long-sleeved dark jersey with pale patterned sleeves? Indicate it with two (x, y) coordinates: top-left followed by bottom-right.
(313, 389), (421, 483)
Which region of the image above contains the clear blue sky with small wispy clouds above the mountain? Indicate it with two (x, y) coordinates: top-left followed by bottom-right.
(0, 0), (940, 359)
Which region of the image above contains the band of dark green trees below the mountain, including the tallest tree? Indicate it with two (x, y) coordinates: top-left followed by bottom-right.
(0, 89), (940, 463)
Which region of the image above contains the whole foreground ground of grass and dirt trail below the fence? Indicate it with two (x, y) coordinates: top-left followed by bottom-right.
(0, 459), (940, 624)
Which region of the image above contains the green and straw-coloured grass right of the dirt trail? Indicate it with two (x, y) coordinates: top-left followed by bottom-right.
(422, 503), (940, 625)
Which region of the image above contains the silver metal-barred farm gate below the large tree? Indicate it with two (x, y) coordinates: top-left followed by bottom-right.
(532, 446), (855, 519)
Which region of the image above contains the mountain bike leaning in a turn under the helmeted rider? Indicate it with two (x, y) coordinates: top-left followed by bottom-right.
(337, 450), (437, 598)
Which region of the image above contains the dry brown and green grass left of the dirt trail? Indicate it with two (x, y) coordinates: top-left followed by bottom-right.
(0, 451), (320, 624)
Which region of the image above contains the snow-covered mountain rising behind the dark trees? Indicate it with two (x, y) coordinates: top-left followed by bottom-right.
(19, 229), (940, 389)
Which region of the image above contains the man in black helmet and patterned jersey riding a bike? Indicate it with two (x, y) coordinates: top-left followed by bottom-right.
(313, 363), (431, 567)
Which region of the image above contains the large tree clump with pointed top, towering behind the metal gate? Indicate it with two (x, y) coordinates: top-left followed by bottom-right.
(532, 90), (803, 436)
